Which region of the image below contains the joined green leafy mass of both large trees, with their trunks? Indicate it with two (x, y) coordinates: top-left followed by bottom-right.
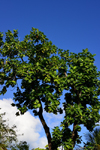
(0, 28), (100, 150)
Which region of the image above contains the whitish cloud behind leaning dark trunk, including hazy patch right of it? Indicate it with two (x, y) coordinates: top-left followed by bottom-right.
(0, 98), (64, 149)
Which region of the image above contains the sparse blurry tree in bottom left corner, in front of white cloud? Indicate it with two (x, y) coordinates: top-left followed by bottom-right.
(0, 108), (29, 150)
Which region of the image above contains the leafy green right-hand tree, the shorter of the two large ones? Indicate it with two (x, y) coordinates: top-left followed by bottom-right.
(53, 49), (100, 149)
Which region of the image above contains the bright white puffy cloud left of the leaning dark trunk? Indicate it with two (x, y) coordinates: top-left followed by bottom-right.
(0, 99), (47, 148)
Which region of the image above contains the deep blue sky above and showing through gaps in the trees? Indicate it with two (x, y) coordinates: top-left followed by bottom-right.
(0, 0), (100, 149)
